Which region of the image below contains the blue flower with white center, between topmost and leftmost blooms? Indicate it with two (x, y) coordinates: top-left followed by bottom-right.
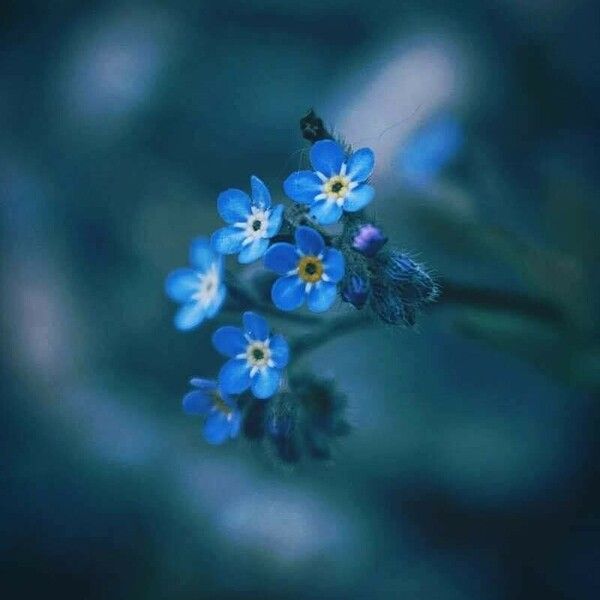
(211, 175), (283, 264)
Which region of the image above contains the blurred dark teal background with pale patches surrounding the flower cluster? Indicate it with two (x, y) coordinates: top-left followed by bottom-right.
(0, 0), (600, 600)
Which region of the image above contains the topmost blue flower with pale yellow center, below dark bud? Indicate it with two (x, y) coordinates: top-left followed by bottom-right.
(283, 140), (375, 225)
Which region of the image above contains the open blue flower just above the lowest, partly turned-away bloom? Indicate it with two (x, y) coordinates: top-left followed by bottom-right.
(212, 312), (289, 400)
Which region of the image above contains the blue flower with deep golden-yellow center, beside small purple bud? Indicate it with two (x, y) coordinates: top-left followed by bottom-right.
(264, 227), (344, 312)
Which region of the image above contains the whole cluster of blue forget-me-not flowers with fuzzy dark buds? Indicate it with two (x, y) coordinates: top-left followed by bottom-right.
(165, 116), (437, 454)
